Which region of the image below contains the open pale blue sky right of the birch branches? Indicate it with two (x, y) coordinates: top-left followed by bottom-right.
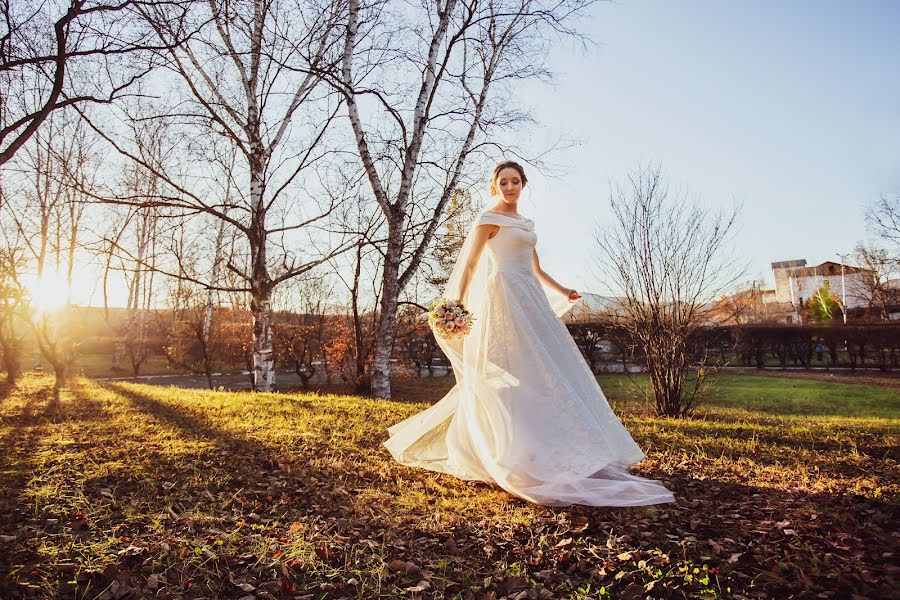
(510, 0), (900, 293)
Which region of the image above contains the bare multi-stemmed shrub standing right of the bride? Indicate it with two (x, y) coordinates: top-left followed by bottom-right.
(596, 167), (742, 417)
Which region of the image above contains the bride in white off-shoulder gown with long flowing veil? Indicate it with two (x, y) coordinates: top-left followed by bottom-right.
(384, 162), (674, 506)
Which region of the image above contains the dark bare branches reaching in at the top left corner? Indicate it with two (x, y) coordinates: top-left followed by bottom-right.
(0, 0), (189, 166)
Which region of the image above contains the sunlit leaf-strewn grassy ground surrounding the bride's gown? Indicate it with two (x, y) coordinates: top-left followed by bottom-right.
(0, 376), (900, 600)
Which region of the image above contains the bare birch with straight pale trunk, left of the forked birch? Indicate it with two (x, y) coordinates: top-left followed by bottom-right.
(81, 0), (344, 391)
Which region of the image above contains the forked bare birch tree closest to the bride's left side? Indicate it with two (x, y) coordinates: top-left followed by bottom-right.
(334, 0), (591, 397)
